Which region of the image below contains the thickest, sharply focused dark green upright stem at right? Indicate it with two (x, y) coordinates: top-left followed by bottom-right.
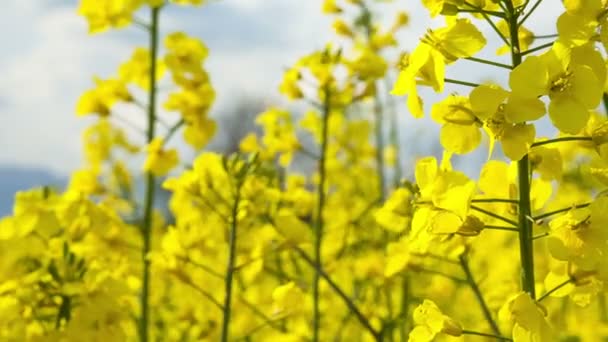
(505, 0), (536, 299)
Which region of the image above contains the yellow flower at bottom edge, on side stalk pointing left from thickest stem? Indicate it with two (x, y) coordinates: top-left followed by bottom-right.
(408, 299), (462, 342)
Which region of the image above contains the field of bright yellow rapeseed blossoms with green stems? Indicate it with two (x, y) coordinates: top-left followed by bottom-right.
(0, 0), (608, 342)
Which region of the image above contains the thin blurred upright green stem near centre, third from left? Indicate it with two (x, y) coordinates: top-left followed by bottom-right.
(312, 85), (331, 342)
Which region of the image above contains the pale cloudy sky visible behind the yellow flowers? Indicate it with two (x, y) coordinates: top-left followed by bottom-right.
(0, 0), (562, 179)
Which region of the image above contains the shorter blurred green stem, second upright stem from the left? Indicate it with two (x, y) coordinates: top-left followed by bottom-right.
(221, 180), (242, 342)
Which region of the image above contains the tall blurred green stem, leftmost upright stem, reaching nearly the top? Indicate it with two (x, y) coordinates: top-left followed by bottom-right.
(139, 8), (160, 342)
